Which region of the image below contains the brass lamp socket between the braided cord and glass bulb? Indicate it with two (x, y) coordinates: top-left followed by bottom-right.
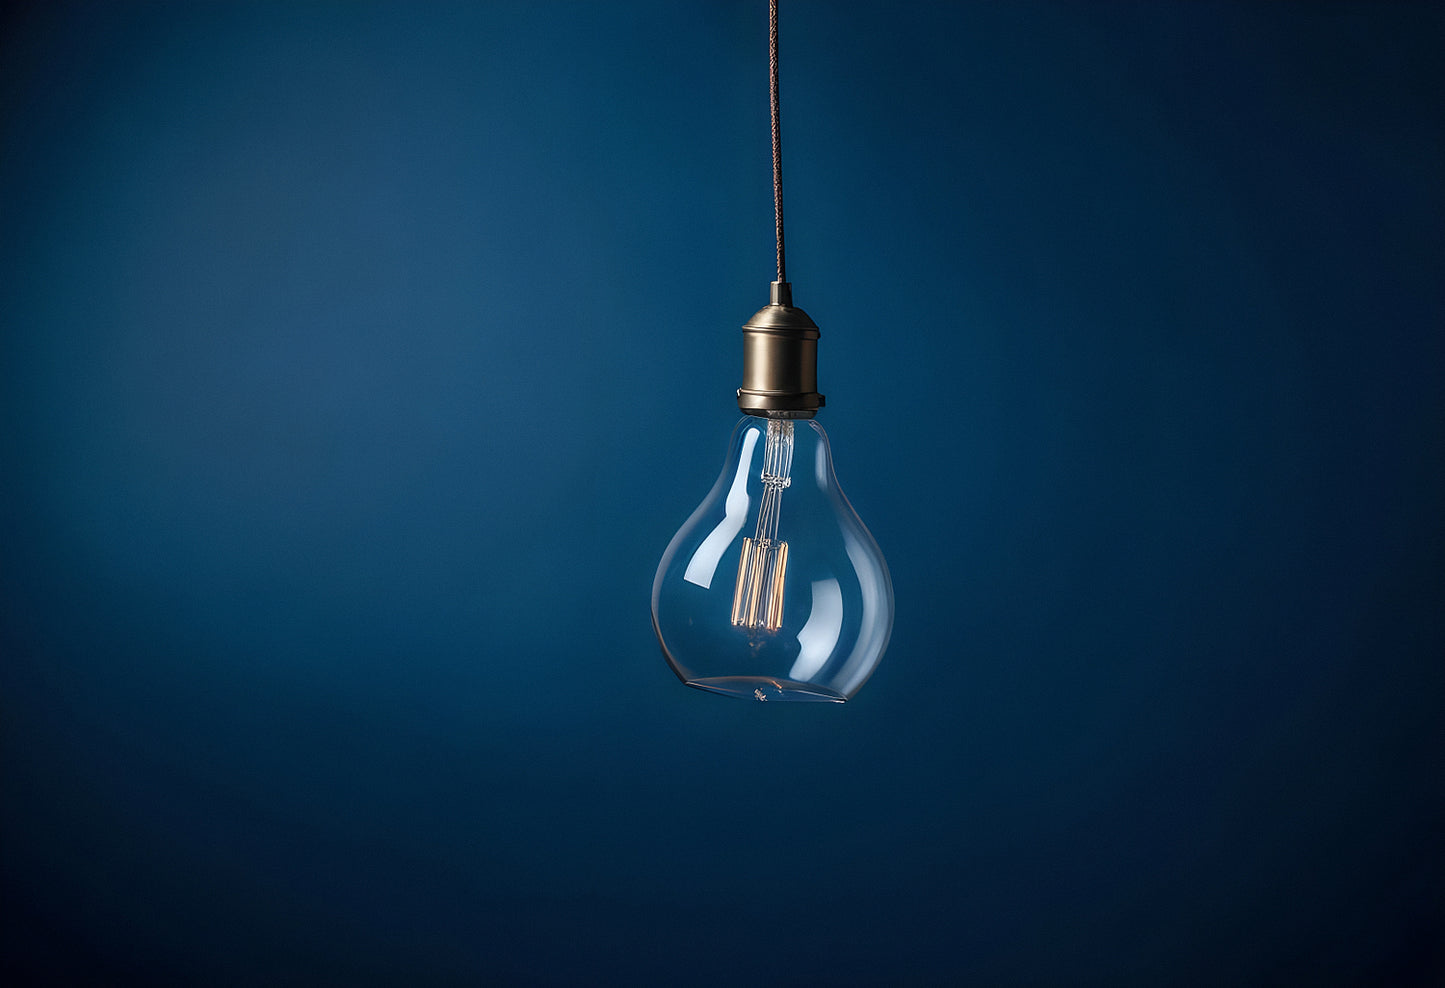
(737, 282), (824, 419)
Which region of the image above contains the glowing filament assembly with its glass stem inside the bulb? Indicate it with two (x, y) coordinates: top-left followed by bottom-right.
(733, 419), (793, 631)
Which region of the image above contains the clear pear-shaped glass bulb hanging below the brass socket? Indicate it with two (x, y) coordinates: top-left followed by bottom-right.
(652, 416), (893, 703)
